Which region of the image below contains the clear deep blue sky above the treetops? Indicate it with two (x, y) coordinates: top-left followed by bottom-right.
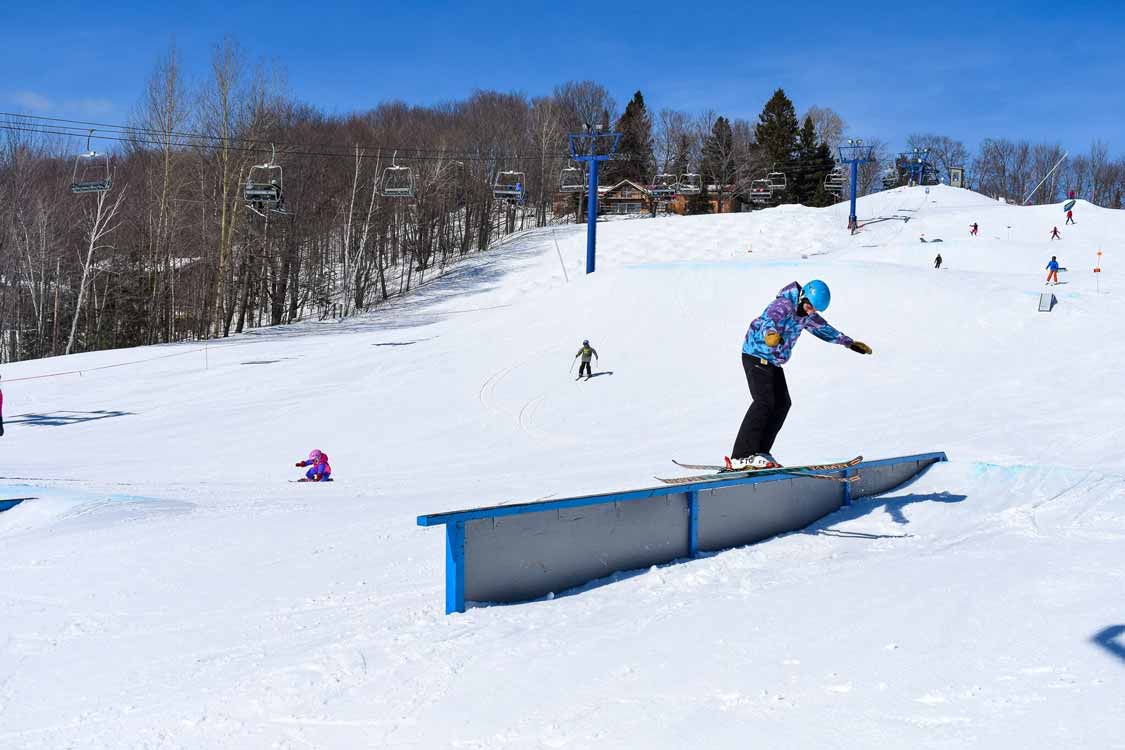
(0, 0), (1125, 155)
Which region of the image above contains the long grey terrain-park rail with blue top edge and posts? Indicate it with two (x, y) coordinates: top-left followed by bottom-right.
(417, 452), (946, 614)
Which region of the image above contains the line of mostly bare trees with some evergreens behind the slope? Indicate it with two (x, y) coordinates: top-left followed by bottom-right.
(0, 39), (1125, 362)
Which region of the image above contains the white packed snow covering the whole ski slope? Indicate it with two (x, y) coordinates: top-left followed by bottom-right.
(0, 187), (1125, 750)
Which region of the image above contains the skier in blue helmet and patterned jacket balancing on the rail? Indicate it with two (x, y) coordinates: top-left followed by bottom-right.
(726, 280), (871, 471)
